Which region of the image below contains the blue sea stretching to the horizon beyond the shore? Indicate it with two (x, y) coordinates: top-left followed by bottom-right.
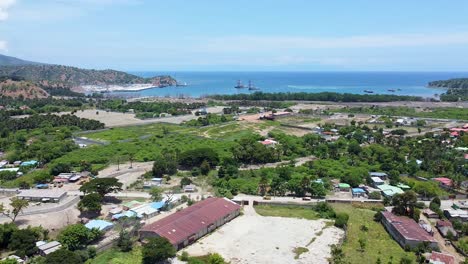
(116, 72), (468, 97)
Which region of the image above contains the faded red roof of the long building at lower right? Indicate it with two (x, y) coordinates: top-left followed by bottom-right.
(382, 211), (436, 242)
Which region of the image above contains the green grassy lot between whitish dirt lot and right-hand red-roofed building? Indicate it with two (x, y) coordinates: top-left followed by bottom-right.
(333, 204), (416, 263)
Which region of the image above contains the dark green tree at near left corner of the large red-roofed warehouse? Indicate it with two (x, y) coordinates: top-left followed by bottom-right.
(142, 237), (176, 264)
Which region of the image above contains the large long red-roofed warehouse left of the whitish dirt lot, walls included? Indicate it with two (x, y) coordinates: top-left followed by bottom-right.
(140, 198), (240, 249)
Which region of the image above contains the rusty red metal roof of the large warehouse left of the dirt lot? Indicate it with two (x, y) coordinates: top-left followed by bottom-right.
(141, 198), (240, 245)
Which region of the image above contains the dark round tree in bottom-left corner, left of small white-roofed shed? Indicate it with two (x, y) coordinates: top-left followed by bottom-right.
(8, 228), (39, 257)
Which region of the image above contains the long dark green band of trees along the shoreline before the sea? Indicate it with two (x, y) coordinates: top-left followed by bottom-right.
(210, 92), (423, 102)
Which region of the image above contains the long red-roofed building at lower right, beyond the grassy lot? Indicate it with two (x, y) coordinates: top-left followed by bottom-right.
(382, 211), (437, 248)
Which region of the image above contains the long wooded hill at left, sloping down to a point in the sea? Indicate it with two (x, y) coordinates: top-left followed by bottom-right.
(0, 64), (176, 88)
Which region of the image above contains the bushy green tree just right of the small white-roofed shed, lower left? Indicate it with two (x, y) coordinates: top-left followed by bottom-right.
(58, 224), (102, 250)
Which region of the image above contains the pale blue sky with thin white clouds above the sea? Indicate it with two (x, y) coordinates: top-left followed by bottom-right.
(0, 0), (468, 71)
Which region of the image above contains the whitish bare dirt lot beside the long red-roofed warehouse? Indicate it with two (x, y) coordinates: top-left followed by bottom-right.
(182, 203), (343, 264)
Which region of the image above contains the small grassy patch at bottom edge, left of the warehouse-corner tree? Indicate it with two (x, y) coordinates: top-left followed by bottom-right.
(88, 247), (142, 264)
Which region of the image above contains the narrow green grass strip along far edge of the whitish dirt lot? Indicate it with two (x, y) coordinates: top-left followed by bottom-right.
(254, 205), (319, 220)
